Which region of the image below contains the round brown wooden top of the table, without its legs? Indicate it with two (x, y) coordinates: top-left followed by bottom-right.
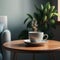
(3, 40), (60, 52)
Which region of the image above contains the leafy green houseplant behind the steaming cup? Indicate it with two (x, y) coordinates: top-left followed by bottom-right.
(19, 2), (58, 39)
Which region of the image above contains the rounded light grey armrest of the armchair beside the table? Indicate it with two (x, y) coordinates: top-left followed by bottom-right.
(1, 29), (11, 43)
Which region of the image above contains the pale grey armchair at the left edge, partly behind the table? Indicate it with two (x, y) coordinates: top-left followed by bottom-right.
(0, 16), (11, 60)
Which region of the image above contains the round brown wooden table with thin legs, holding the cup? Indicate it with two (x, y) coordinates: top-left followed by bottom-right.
(3, 40), (60, 60)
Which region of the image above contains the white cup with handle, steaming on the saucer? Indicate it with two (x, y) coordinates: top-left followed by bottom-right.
(29, 31), (48, 43)
